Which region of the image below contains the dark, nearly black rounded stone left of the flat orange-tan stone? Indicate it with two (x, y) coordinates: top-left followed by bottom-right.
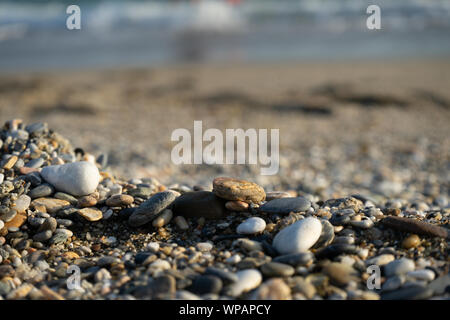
(172, 191), (227, 219)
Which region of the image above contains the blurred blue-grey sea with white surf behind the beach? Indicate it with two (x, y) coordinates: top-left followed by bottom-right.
(0, 0), (450, 72)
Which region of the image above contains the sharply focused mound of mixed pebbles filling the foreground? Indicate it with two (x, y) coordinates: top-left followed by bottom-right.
(0, 119), (450, 300)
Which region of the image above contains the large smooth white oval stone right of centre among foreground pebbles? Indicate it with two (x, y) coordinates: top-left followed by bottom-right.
(272, 218), (322, 254)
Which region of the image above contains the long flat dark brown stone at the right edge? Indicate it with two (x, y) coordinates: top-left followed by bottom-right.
(381, 216), (450, 238)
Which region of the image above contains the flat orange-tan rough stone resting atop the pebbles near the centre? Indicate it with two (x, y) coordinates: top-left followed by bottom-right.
(213, 177), (266, 203)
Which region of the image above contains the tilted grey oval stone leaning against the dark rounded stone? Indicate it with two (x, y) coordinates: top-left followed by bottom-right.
(128, 190), (179, 227)
